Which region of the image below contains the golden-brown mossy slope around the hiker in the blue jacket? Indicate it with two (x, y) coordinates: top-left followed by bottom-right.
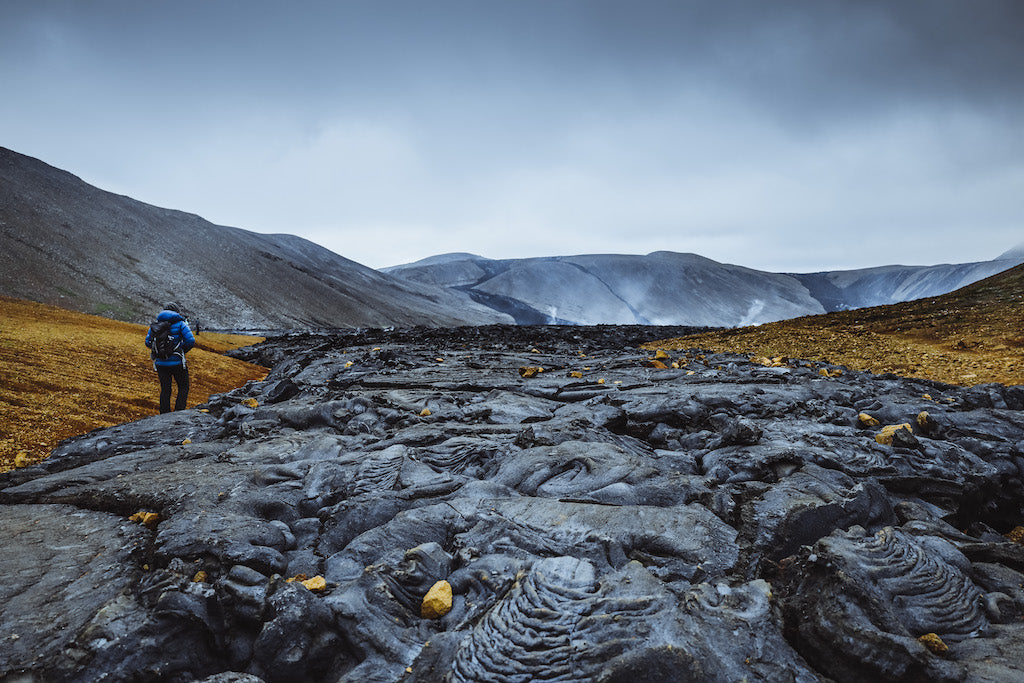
(0, 297), (266, 471)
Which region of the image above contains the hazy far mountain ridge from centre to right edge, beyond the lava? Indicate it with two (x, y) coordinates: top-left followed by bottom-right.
(384, 246), (1024, 327)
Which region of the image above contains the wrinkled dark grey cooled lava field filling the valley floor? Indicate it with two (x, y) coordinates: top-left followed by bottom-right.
(0, 327), (1024, 683)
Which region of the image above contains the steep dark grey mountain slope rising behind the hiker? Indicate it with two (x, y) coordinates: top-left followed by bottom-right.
(0, 147), (511, 329)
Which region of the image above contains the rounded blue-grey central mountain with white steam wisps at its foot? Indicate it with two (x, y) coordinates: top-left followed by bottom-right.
(386, 252), (824, 327)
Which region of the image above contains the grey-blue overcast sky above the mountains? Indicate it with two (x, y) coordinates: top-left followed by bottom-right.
(0, 0), (1024, 271)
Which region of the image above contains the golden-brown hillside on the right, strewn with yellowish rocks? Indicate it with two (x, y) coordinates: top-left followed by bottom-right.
(644, 265), (1024, 385)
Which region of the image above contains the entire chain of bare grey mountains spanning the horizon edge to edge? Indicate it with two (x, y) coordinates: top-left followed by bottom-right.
(0, 147), (1024, 330)
